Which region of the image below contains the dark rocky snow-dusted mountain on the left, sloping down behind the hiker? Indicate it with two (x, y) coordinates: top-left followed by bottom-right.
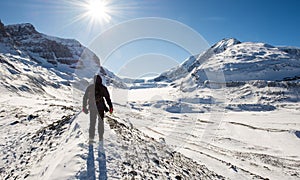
(0, 20), (126, 91)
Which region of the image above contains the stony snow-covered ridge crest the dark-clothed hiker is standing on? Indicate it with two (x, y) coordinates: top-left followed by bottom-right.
(13, 110), (224, 179)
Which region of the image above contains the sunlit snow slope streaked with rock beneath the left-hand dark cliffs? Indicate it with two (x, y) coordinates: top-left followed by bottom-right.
(0, 53), (72, 97)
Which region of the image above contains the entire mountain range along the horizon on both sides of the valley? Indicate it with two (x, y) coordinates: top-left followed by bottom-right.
(0, 23), (300, 94)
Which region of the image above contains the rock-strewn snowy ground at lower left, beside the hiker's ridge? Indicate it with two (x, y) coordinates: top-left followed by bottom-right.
(0, 95), (76, 179)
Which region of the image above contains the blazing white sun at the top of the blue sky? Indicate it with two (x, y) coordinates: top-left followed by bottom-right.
(85, 0), (111, 23)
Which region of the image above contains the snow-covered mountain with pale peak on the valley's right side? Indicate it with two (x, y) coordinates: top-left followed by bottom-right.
(155, 38), (300, 83)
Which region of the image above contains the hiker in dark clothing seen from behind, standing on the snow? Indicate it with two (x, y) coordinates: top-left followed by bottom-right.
(82, 75), (113, 143)
